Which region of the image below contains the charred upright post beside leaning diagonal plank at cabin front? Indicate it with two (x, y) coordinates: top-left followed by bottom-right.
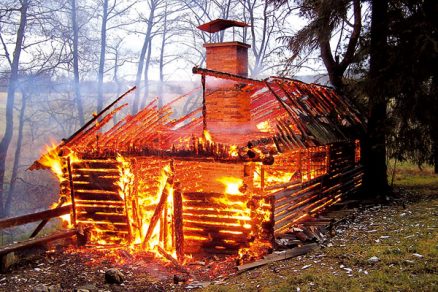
(173, 183), (184, 263)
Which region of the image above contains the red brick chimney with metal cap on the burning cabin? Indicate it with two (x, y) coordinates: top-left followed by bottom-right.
(198, 19), (251, 144)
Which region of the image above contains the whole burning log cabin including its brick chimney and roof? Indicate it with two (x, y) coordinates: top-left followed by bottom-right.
(33, 20), (363, 260)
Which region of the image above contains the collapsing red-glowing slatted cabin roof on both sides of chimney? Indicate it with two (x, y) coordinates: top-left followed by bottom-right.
(30, 67), (364, 168)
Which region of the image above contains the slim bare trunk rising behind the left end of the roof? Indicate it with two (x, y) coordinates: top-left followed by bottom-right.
(71, 0), (85, 125)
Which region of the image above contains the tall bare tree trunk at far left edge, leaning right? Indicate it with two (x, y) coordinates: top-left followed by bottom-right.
(0, 0), (29, 218)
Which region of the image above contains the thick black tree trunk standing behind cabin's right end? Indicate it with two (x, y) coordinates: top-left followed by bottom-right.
(363, 0), (389, 197)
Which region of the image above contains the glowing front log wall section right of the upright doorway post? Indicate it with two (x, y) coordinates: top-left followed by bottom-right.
(183, 192), (252, 253)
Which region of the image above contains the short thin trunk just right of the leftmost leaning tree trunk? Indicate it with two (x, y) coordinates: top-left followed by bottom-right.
(5, 90), (28, 216)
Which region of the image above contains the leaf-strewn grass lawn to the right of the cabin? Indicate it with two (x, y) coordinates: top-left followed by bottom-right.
(205, 163), (438, 292)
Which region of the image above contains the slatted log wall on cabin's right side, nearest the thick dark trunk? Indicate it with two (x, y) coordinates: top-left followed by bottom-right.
(271, 143), (363, 235)
